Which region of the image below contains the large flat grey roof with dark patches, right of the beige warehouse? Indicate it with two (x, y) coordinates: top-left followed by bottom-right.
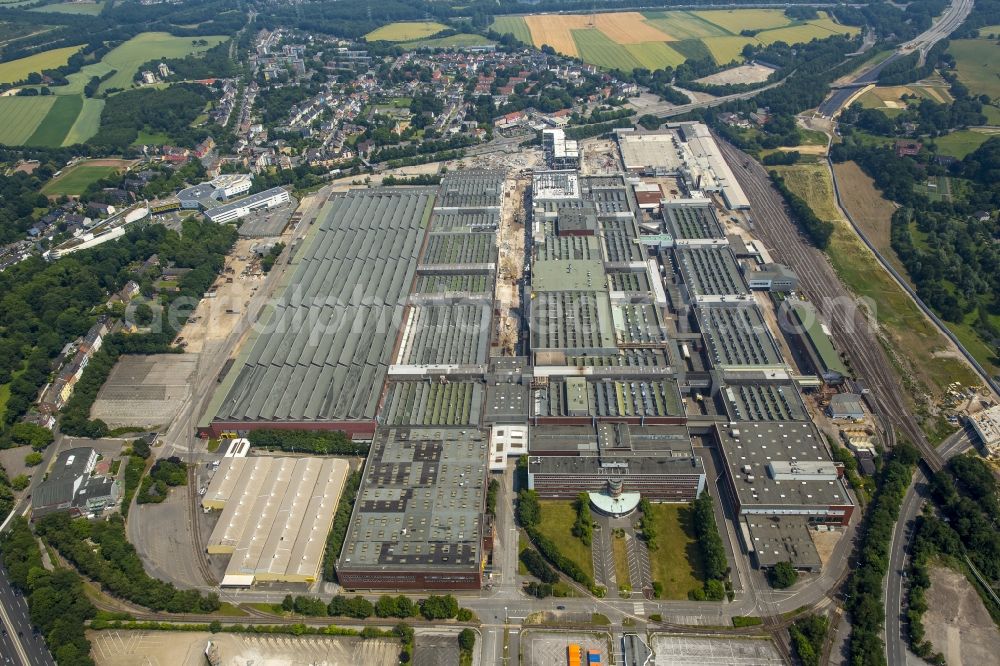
(337, 428), (488, 571)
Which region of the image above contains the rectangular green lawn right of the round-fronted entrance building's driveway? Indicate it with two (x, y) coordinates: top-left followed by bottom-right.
(649, 504), (705, 599)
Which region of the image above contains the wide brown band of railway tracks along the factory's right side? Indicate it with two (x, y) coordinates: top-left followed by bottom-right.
(717, 137), (944, 471)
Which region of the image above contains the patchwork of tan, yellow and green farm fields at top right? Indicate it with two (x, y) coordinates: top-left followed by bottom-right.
(492, 9), (857, 70)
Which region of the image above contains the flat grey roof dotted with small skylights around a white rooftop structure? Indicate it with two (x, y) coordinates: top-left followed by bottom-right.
(716, 421), (852, 512)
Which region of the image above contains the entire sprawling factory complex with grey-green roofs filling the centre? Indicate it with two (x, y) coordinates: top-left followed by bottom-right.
(201, 123), (853, 589)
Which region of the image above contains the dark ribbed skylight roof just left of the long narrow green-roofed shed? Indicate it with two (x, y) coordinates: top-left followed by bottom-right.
(695, 303), (783, 367)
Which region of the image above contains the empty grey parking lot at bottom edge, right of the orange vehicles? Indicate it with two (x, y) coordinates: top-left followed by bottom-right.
(652, 634), (785, 666)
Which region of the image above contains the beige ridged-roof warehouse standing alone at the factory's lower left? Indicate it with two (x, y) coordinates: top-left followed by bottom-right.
(202, 457), (349, 587)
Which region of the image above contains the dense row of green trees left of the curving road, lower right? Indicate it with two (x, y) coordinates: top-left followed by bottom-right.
(847, 442), (920, 666)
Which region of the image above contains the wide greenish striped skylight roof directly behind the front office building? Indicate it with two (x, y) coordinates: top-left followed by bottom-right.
(532, 379), (684, 418)
